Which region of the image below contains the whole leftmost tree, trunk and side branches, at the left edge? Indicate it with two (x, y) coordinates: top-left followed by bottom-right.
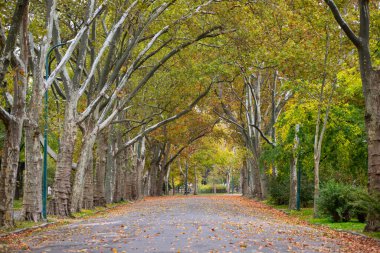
(0, 0), (29, 227)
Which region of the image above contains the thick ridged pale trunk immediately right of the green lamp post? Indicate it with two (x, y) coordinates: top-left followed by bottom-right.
(48, 99), (77, 217)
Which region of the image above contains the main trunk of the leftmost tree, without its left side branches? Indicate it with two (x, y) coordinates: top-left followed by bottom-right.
(0, 8), (29, 227)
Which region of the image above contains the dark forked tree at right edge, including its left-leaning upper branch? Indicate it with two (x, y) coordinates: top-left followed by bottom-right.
(325, 0), (380, 231)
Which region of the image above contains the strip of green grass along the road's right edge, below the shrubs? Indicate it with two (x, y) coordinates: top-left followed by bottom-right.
(264, 201), (380, 239)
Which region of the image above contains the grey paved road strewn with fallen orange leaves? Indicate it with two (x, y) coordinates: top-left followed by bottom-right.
(14, 196), (380, 253)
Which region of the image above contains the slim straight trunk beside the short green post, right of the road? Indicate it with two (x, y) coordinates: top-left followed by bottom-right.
(289, 124), (300, 209)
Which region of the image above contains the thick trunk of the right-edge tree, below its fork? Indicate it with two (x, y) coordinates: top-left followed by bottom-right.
(365, 70), (380, 231)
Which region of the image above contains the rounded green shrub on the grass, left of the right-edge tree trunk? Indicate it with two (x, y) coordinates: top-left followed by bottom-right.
(318, 181), (357, 222)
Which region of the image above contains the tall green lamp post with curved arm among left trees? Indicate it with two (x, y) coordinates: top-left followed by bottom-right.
(42, 41), (71, 220)
